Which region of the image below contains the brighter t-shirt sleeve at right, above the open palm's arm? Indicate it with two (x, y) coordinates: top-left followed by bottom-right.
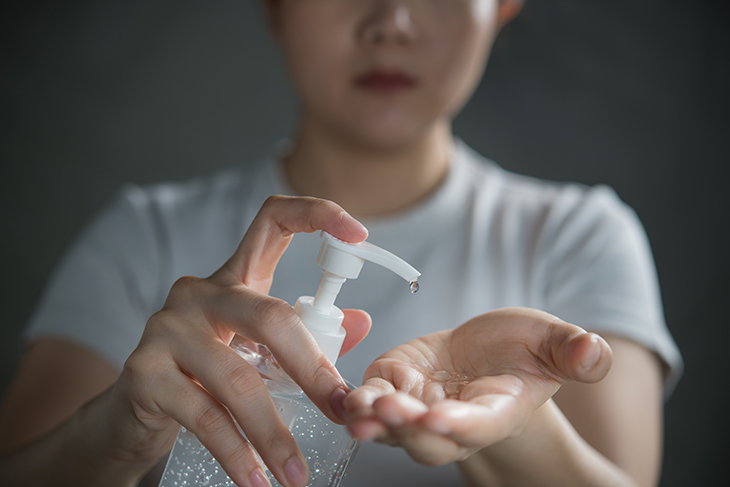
(545, 186), (682, 394)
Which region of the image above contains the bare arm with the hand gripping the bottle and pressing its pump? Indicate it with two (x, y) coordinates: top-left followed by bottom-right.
(0, 197), (369, 487)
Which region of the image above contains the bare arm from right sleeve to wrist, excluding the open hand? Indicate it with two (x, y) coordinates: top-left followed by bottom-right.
(459, 337), (662, 487)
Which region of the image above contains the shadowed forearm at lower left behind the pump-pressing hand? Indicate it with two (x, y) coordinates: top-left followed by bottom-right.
(0, 395), (153, 487)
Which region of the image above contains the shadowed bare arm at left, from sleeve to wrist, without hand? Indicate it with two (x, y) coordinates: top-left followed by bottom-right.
(0, 339), (146, 485)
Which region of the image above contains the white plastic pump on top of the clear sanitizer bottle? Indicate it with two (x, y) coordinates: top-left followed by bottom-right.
(294, 231), (421, 364)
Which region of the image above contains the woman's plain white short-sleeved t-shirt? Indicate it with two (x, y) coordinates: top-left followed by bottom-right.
(25, 143), (682, 487)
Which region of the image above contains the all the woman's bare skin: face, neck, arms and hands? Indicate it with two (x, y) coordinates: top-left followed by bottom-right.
(0, 0), (661, 487)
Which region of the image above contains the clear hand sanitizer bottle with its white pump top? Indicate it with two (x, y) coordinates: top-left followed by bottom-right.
(160, 232), (421, 487)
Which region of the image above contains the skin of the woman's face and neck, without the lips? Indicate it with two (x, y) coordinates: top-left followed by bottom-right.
(276, 0), (519, 217)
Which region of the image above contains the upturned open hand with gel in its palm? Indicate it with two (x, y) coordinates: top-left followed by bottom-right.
(345, 308), (612, 465)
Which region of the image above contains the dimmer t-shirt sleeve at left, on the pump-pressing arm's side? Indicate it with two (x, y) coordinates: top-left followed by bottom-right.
(23, 185), (165, 370)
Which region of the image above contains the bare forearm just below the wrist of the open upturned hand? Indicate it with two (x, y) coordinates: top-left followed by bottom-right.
(459, 400), (636, 487)
